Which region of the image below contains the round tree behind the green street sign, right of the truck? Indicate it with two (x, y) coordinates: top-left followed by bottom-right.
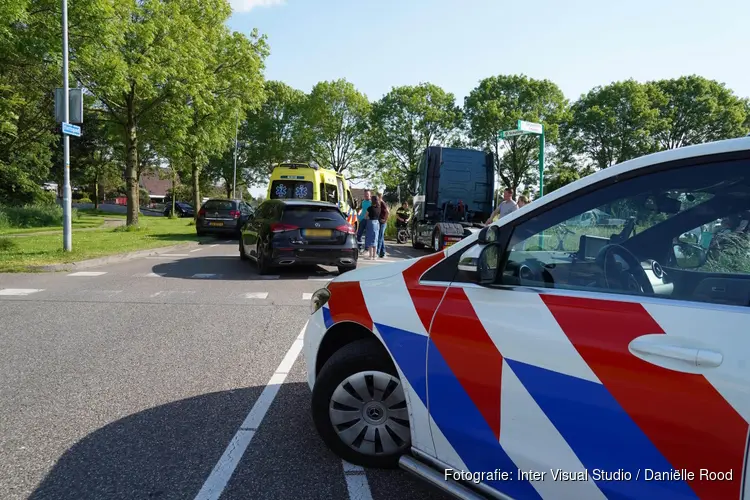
(464, 75), (568, 192)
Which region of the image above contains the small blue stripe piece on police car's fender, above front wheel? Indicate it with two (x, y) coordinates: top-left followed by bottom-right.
(375, 323), (427, 406)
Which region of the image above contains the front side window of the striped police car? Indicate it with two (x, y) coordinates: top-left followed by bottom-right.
(500, 161), (750, 305)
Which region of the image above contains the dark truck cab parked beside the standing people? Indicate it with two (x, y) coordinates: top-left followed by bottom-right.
(411, 146), (495, 252)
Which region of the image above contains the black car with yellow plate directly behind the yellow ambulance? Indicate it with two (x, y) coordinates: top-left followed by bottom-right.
(239, 199), (359, 274)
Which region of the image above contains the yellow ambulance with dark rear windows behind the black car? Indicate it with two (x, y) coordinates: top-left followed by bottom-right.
(267, 163), (357, 229)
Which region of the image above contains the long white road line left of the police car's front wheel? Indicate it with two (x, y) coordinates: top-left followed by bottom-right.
(195, 323), (307, 500)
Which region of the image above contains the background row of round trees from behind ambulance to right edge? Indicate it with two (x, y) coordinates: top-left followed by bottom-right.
(240, 75), (750, 199)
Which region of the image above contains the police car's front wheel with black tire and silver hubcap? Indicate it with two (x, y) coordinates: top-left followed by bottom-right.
(312, 339), (411, 468)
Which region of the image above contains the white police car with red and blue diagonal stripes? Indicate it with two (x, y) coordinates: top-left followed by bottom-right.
(304, 138), (750, 500)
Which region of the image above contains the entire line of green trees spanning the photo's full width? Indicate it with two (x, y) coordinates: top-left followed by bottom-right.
(0, 0), (750, 224)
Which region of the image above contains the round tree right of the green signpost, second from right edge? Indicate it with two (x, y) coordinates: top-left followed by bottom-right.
(566, 80), (659, 169)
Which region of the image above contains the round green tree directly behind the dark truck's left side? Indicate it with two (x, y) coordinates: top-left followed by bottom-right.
(368, 83), (461, 194)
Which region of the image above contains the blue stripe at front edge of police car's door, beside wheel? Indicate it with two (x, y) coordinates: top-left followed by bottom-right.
(427, 343), (540, 499)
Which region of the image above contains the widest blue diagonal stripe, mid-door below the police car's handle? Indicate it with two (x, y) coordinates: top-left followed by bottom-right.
(506, 358), (700, 499)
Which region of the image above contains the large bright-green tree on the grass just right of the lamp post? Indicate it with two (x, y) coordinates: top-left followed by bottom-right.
(71, 0), (251, 225)
